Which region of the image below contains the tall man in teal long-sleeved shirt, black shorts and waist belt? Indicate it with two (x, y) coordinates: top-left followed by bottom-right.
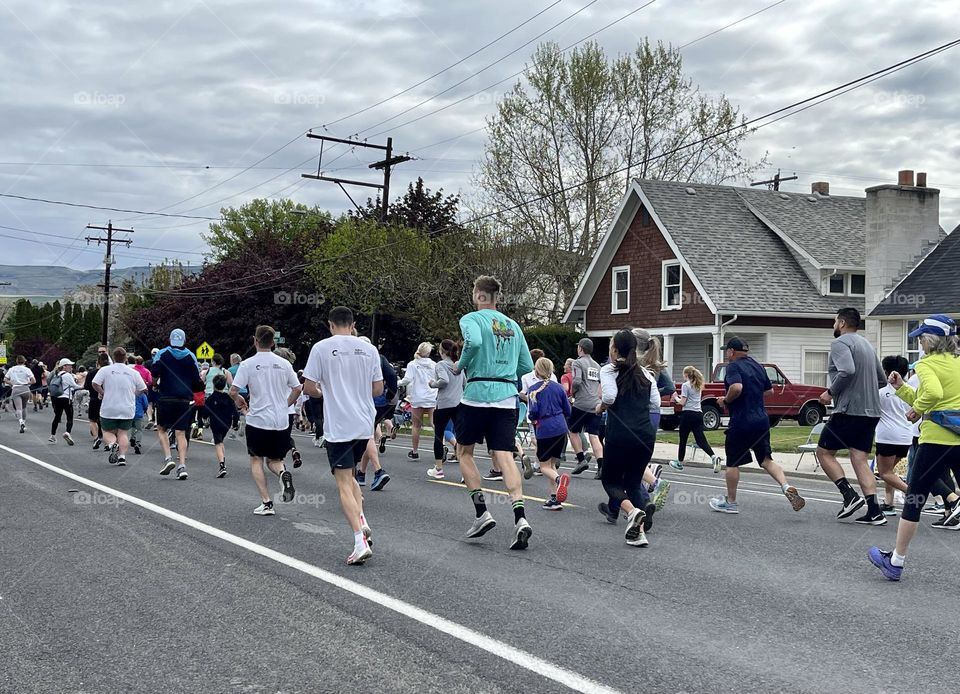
(455, 275), (533, 550)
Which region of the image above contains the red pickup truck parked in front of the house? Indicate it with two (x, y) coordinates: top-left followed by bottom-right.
(660, 363), (827, 431)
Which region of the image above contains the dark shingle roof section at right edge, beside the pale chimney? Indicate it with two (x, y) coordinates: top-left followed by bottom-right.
(870, 227), (960, 316)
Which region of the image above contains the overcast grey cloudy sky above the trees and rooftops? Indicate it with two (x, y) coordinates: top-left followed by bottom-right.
(0, 0), (960, 270)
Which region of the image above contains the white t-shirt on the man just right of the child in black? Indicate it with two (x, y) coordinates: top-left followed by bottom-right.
(233, 351), (300, 431)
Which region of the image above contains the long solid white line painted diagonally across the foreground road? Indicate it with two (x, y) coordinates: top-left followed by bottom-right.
(0, 444), (620, 694)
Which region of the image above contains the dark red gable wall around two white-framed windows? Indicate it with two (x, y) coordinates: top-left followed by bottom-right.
(587, 205), (714, 331)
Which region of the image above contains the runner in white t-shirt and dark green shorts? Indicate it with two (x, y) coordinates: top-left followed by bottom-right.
(93, 347), (147, 466)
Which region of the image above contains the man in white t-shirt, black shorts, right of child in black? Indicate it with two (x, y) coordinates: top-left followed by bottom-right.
(230, 325), (301, 516)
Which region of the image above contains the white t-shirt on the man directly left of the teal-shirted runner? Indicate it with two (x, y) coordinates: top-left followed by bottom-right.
(303, 335), (383, 443)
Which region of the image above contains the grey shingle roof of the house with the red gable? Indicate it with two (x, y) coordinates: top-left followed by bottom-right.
(637, 180), (865, 314)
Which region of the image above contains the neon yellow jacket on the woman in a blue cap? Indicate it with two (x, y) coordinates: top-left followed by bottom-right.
(897, 353), (960, 446)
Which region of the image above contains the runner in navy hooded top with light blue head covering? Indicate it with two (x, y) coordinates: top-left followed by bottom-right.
(151, 328), (203, 480)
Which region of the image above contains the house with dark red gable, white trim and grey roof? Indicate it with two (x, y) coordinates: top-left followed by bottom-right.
(564, 173), (940, 386)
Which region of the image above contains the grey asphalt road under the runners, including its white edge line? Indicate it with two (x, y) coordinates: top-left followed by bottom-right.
(0, 410), (960, 694)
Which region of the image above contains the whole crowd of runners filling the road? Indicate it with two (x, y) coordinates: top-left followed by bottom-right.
(2, 276), (960, 580)
